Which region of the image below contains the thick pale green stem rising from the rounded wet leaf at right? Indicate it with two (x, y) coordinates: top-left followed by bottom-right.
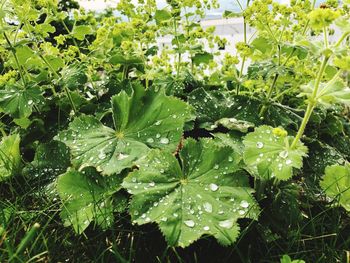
(291, 57), (329, 149)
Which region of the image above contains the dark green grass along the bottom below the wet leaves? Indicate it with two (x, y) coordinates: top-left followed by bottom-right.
(0, 173), (350, 263)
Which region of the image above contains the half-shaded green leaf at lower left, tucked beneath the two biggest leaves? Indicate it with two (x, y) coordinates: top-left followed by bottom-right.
(57, 167), (122, 234)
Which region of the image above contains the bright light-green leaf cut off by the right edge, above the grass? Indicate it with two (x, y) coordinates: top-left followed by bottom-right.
(320, 163), (350, 212)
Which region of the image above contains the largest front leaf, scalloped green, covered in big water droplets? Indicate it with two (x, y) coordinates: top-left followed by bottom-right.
(123, 139), (259, 247)
